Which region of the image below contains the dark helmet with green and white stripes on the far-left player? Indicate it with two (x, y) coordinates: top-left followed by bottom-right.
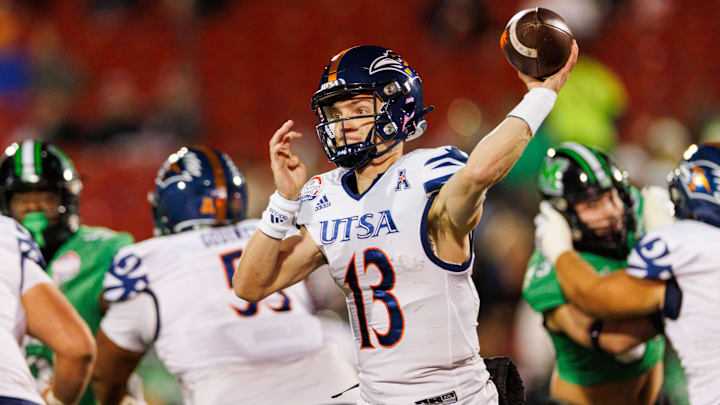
(0, 140), (82, 252)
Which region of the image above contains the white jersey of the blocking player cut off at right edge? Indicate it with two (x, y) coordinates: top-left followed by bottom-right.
(627, 220), (720, 405)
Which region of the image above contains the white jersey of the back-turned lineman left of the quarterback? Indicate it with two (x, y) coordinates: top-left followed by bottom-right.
(101, 220), (357, 405)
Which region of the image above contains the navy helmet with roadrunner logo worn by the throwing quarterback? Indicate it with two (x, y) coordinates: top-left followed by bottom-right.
(311, 46), (434, 169)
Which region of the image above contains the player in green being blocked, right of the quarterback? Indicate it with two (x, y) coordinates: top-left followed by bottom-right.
(523, 142), (665, 405)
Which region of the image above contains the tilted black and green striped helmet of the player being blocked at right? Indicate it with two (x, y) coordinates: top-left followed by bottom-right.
(536, 142), (637, 259)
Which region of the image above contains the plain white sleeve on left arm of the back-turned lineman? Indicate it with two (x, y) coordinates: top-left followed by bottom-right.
(100, 293), (160, 353)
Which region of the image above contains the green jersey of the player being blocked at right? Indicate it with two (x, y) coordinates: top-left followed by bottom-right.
(522, 188), (665, 385)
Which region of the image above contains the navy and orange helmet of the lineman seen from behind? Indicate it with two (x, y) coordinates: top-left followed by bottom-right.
(148, 146), (247, 235)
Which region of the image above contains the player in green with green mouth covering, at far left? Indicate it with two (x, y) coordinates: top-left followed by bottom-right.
(0, 140), (133, 405)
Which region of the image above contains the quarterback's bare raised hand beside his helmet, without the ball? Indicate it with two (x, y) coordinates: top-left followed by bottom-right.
(270, 120), (307, 200)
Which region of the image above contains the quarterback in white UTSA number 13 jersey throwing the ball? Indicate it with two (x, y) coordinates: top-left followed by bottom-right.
(233, 46), (577, 404)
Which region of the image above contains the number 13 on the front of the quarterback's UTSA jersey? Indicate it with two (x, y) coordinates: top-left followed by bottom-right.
(344, 248), (405, 349)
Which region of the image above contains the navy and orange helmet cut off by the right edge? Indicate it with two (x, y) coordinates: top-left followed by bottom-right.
(668, 143), (720, 227)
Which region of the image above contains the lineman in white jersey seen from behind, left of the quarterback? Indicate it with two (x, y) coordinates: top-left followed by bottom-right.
(94, 146), (357, 405)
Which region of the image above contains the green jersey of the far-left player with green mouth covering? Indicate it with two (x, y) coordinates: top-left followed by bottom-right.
(25, 226), (133, 405)
